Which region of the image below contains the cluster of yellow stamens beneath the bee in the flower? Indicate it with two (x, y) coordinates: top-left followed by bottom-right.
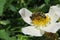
(32, 16), (51, 26)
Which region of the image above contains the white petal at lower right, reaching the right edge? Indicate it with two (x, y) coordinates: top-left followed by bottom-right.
(41, 22), (60, 33)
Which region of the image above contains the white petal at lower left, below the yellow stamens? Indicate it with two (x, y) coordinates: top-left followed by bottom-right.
(22, 26), (44, 36)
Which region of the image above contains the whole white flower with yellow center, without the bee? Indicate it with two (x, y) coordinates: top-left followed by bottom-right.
(19, 5), (60, 36)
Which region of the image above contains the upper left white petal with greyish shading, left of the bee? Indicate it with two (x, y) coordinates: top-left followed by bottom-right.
(19, 8), (32, 24)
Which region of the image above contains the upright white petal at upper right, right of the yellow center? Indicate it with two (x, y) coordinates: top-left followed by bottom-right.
(48, 5), (60, 23)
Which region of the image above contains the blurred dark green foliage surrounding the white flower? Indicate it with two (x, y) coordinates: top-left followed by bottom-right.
(0, 0), (60, 40)
